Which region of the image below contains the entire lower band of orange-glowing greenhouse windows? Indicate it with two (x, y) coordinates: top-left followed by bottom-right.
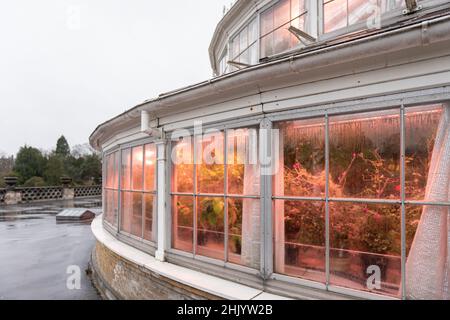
(104, 104), (450, 298)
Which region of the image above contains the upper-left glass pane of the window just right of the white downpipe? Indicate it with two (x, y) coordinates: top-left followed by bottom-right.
(172, 139), (194, 193)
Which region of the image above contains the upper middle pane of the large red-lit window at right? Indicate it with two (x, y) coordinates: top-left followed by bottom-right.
(330, 110), (400, 199)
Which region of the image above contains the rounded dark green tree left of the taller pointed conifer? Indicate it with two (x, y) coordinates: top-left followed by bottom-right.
(14, 146), (46, 184)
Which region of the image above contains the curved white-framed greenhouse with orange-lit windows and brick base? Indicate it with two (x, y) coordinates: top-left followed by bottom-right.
(91, 0), (450, 300)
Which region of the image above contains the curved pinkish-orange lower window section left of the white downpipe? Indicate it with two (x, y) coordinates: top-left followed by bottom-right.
(104, 144), (157, 242)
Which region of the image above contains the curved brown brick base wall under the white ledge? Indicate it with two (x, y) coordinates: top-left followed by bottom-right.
(91, 242), (223, 300)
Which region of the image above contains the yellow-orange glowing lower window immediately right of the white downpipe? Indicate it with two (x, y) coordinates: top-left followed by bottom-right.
(172, 128), (261, 269)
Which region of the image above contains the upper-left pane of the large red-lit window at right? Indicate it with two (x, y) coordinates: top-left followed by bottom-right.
(273, 118), (326, 197)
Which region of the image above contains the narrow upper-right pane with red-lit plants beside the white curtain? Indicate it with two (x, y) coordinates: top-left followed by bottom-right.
(405, 105), (445, 200)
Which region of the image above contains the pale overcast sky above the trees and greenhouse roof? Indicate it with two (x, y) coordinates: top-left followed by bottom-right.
(0, 0), (231, 154)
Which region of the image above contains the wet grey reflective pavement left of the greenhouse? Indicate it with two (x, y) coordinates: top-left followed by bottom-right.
(0, 199), (101, 300)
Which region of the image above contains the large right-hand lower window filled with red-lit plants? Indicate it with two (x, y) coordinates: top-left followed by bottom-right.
(273, 105), (448, 297)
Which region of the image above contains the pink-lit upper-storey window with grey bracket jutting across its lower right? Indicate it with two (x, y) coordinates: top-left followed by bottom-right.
(261, 0), (308, 57)
